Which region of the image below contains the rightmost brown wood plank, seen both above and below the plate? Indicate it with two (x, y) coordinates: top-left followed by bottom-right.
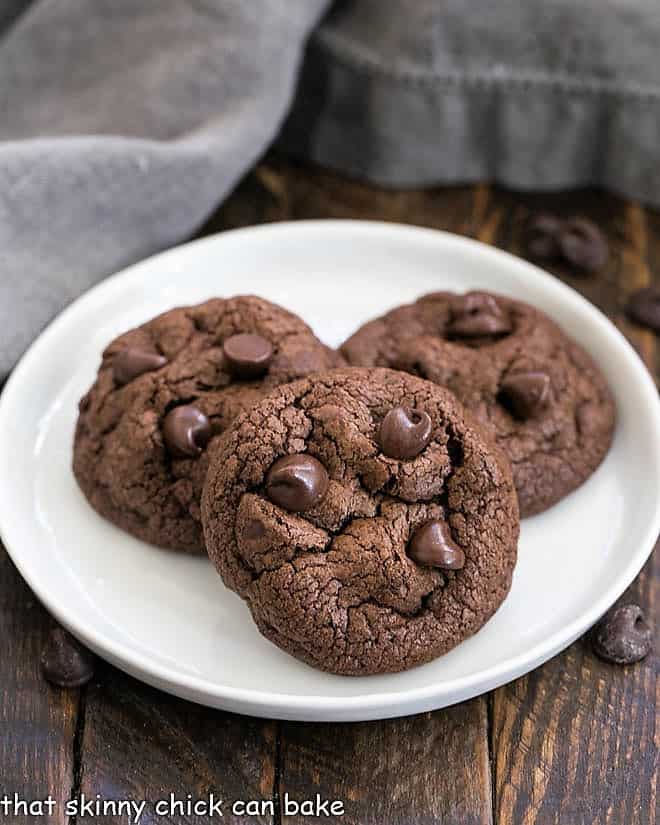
(491, 188), (660, 825)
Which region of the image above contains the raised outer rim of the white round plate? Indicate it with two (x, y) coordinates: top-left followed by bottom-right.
(0, 219), (660, 721)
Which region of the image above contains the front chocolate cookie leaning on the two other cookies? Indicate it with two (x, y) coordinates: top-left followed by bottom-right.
(202, 369), (519, 675)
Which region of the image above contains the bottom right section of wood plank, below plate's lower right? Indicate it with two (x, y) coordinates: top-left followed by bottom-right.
(492, 551), (660, 825)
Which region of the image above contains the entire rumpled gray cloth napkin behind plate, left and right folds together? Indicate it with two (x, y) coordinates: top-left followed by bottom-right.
(0, 0), (660, 380)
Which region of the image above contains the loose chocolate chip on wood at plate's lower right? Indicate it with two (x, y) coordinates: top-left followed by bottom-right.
(591, 604), (653, 665)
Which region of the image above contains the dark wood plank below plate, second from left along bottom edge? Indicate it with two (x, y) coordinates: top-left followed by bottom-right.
(77, 665), (276, 825)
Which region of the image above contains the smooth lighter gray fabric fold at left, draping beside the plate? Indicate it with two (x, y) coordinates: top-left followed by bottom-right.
(0, 0), (328, 380)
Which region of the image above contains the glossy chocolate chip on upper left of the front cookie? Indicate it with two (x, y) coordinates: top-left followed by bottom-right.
(266, 453), (328, 513)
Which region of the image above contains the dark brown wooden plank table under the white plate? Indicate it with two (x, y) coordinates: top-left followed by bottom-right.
(0, 158), (660, 825)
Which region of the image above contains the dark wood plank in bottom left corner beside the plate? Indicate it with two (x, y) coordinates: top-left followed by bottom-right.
(0, 545), (80, 825)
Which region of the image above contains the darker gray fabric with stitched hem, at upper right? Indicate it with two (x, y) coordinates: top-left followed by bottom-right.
(280, 0), (660, 198)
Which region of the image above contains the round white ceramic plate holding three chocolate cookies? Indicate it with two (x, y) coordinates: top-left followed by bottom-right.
(0, 221), (660, 720)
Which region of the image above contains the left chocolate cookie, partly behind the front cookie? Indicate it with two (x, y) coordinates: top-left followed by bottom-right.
(73, 296), (343, 553)
